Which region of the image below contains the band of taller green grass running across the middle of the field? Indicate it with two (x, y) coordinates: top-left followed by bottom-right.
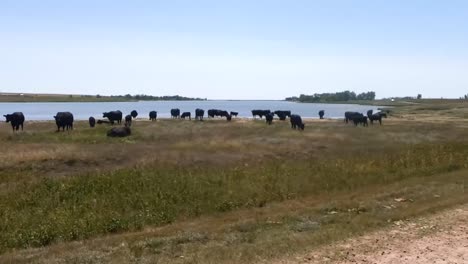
(0, 143), (468, 251)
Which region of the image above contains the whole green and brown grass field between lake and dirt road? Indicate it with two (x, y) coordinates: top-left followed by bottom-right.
(0, 101), (468, 263)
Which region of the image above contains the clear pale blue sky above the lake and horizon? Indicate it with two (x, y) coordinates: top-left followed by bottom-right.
(0, 0), (468, 99)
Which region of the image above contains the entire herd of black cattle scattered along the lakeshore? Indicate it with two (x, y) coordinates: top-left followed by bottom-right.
(0, 108), (387, 137)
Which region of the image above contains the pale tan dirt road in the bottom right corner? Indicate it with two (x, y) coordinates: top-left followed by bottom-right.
(276, 205), (468, 264)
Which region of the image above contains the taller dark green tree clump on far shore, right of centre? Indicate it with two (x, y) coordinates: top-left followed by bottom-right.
(285, 91), (375, 103)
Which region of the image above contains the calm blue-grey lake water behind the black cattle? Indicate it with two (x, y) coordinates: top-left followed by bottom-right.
(0, 101), (384, 120)
